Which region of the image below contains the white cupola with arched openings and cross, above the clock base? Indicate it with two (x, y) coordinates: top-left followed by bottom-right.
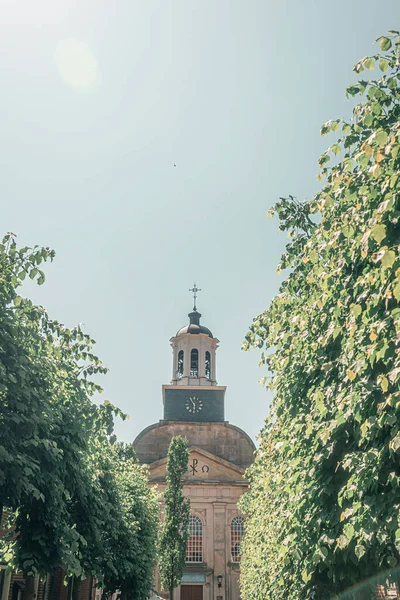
(170, 284), (219, 386)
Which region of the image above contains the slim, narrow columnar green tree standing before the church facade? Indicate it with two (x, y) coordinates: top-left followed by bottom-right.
(158, 436), (190, 599)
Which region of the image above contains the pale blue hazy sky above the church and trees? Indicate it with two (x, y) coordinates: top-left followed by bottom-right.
(0, 0), (400, 441)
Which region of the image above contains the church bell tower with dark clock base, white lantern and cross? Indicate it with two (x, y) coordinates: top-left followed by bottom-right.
(163, 284), (226, 421)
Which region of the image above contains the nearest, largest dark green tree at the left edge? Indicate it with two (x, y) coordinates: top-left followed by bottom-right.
(0, 234), (123, 598)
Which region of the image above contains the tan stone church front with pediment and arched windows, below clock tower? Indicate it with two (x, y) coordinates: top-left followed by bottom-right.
(134, 421), (254, 600)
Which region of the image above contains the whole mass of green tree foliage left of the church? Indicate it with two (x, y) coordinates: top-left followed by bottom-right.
(0, 234), (158, 600)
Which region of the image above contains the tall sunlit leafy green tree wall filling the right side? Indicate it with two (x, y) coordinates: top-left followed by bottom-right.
(241, 31), (400, 600)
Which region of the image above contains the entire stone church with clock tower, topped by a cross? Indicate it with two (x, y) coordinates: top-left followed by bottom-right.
(134, 285), (255, 600)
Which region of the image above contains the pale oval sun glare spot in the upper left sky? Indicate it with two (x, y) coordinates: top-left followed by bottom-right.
(55, 39), (99, 90)
